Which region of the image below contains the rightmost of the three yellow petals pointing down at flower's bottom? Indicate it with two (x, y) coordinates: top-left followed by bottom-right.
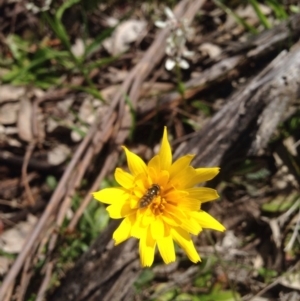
(171, 228), (201, 263)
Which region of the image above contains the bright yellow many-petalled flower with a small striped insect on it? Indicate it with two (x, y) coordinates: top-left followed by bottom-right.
(93, 128), (225, 266)
